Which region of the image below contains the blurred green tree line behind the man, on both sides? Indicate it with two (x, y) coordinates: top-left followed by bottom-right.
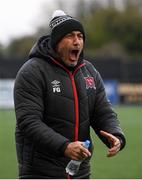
(0, 1), (142, 59)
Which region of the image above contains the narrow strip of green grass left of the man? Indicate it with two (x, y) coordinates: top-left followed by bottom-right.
(0, 110), (18, 179)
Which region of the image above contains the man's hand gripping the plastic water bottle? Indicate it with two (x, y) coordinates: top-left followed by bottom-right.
(65, 141), (91, 160)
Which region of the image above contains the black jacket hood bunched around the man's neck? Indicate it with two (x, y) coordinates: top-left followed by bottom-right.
(29, 35), (83, 68)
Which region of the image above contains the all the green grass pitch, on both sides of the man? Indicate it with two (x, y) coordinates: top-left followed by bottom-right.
(0, 107), (142, 179)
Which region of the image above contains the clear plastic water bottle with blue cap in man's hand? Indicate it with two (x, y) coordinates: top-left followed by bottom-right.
(66, 140), (90, 176)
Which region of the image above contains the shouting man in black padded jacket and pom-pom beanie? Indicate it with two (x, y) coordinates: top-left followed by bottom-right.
(14, 10), (125, 179)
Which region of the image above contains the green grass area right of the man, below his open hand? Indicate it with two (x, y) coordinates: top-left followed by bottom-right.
(92, 107), (142, 179)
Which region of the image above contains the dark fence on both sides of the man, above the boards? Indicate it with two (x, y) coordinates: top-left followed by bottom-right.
(0, 58), (142, 83)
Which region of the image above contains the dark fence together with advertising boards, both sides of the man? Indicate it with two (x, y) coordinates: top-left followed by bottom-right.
(0, 59), (142, 107)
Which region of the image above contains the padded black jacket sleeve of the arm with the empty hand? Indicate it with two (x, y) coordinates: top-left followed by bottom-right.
(91, 71), (126, 149)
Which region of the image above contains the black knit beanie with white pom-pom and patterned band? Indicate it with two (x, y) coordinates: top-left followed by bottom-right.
(49, 10), (85, 49)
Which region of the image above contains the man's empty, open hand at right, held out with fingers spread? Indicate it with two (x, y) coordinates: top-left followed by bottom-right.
(100, 131), (121, 157)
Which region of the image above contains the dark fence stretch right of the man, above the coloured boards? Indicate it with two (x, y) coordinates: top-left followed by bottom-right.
(90, 58), (142, 83)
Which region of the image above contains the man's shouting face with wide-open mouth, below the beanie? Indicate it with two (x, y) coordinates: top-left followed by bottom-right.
(56, 31), (84, 66)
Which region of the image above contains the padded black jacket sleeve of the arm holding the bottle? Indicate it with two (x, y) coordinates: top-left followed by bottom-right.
(14, 60), (69, 155)
